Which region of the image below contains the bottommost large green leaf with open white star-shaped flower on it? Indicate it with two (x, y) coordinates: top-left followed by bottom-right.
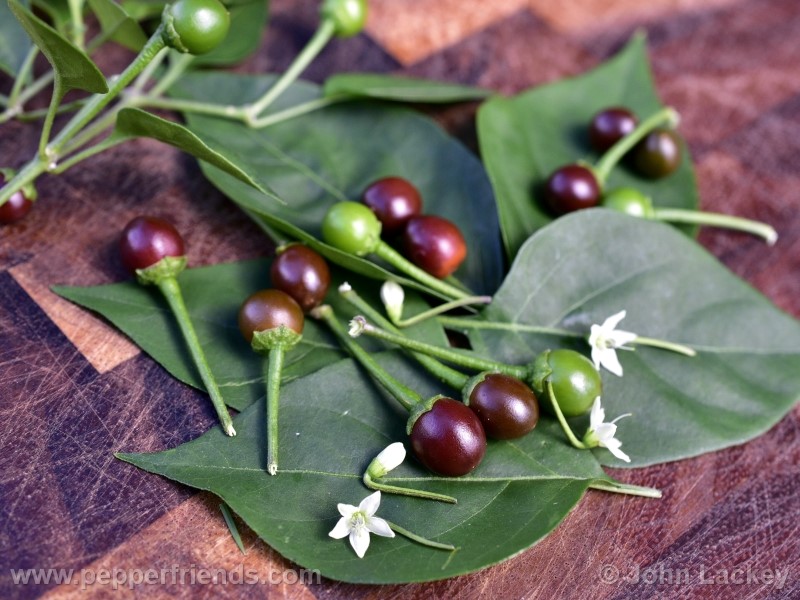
(118, 353), (605, 583)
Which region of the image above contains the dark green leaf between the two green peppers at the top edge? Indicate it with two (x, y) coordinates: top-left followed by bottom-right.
(192, 0), (269, 66)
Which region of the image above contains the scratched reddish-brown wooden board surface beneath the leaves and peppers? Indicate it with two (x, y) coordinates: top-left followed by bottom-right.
(0, 0), (800, 599)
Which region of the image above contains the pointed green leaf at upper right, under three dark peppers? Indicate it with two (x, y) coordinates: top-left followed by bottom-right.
(478, 36), (698, 259)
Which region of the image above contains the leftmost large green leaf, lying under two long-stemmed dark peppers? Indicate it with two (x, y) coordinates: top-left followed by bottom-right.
(54, 260), (454, 410)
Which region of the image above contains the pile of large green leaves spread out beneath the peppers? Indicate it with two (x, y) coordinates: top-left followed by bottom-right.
(0, 0), (800, 583)
